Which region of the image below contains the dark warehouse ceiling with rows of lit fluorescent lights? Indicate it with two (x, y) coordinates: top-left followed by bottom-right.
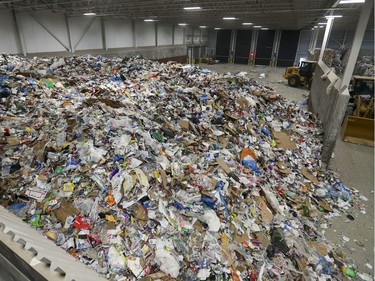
(0, 0), (374, 30)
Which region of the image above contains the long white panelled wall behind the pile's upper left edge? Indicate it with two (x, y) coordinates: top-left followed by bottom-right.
(0, 9), (186, 57)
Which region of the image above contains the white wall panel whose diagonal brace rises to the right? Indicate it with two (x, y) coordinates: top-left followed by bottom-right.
(69, 17), (103, 50)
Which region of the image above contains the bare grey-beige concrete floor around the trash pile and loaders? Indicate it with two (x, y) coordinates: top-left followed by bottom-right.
(200, 64), (374, 280)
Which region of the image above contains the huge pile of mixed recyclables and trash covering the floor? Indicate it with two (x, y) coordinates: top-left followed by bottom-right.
(0, 55), (370, 281)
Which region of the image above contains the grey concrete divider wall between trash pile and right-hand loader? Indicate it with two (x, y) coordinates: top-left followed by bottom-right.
(309, 62), (349, 164)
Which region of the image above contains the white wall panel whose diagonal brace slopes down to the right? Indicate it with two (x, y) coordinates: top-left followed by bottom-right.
(17, 13), (66, 53)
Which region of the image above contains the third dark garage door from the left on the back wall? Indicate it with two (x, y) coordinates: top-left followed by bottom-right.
(255, 30), (275, 65)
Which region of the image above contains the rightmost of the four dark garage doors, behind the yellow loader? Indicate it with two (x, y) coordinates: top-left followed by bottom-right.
(277, 30), (300, 66)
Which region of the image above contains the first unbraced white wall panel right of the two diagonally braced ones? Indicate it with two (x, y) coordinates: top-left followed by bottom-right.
(105, 19), (133, 48)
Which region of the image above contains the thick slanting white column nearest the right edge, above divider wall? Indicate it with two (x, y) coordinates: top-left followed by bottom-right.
(340, 0), (374, 91)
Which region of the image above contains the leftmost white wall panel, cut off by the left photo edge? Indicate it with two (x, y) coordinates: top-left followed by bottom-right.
(0, 11), (18, 54)
